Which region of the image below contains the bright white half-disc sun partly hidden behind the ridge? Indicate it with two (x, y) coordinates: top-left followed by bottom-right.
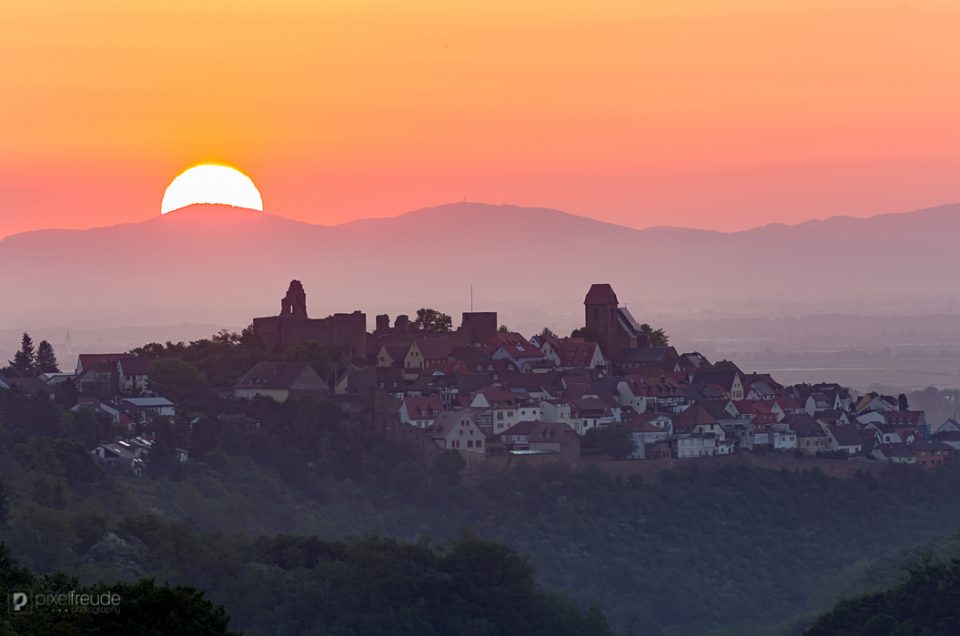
(160, 163), (263, 214)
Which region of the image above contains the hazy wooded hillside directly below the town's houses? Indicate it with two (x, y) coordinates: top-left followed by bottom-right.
(0, 392), (960, 635)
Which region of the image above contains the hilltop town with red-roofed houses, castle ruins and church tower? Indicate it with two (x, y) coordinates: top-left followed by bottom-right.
(0, 281), (960, 474)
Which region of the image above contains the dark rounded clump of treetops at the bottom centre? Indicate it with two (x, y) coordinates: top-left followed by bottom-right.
(240, 536), (613, 636)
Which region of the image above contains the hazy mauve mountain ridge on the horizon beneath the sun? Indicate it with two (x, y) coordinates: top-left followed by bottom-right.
(0, 203), (960, 328)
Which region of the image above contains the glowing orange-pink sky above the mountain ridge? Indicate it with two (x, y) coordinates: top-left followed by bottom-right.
(0, 0), (960, 236)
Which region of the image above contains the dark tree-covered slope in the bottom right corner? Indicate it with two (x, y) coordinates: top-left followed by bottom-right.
(806, 560), (960, 636)
